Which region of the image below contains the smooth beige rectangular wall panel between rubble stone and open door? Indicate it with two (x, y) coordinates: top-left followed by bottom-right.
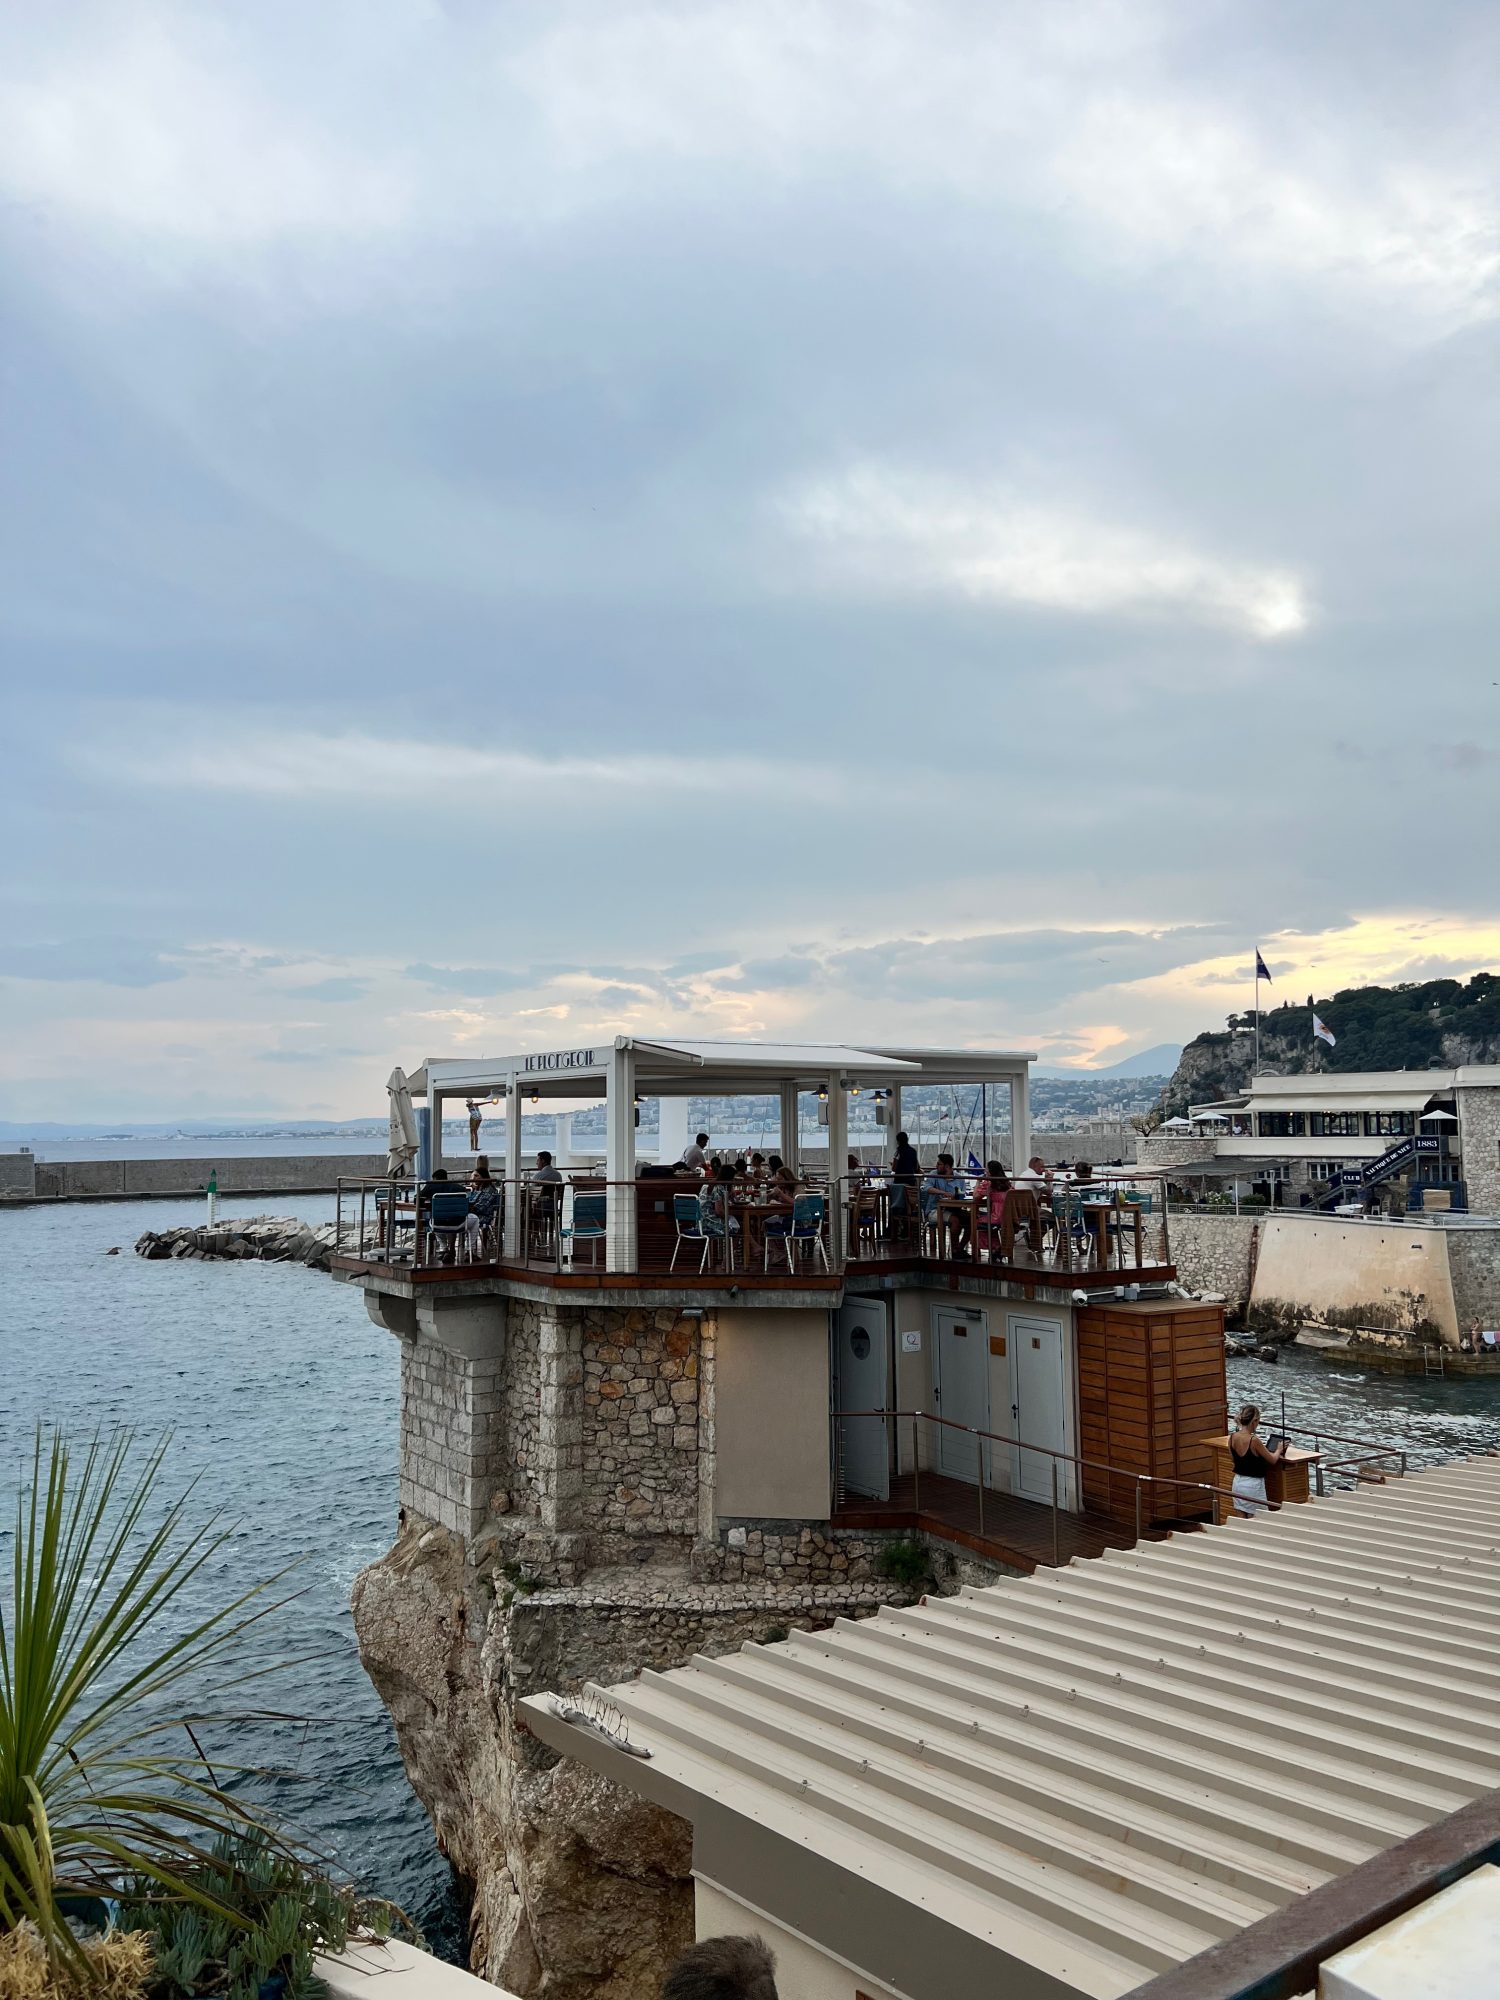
(714, 1306), (830, 1520)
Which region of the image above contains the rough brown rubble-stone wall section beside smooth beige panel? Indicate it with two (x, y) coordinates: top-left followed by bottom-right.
(580, 1308), (714, 1562)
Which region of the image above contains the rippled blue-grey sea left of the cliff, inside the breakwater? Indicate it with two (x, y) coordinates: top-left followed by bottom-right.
(0, 1196), (462, 1956)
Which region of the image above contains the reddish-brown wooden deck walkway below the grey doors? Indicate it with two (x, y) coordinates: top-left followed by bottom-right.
(832, 1472), (1198, 1576)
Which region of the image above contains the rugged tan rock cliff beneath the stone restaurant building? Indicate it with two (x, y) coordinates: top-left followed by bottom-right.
(352, 1522), (904, 2000)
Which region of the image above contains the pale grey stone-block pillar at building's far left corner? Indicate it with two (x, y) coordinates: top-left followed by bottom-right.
(390, 1298), (506, 1540)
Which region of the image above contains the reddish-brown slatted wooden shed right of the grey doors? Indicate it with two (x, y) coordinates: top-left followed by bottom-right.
(1078, 1298), (1228, 1522)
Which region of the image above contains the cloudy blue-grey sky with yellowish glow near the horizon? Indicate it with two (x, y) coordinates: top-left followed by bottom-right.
(0, 0), (1500, 1120)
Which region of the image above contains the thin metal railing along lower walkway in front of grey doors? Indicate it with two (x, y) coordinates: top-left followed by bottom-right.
(832, 1410), (1240, 1568)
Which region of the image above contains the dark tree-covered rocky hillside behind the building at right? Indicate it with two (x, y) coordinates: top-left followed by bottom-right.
(1160, 972), (1500, 1118)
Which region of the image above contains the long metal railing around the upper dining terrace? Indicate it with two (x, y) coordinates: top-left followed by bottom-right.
(334, 1170), (1170, 1292)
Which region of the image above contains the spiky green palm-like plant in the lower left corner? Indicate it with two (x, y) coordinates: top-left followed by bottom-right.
(0, 1428), (292, 1956)
